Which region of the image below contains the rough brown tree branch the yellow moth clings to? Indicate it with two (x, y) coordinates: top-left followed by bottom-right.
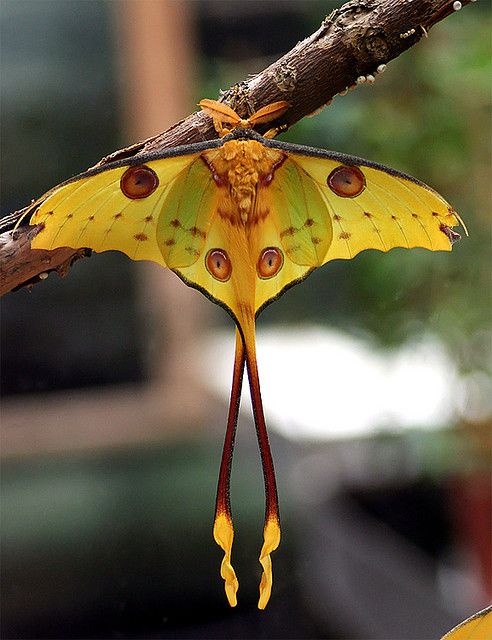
(0, 0), (474, 295)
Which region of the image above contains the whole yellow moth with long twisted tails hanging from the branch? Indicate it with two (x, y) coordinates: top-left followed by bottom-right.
(26, 100), (466, 609)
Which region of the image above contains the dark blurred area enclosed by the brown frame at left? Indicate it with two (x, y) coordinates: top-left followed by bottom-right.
(0, 0), (144, 394)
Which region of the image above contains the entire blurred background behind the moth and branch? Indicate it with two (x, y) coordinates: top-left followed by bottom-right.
(0, 0), (492, 640)
